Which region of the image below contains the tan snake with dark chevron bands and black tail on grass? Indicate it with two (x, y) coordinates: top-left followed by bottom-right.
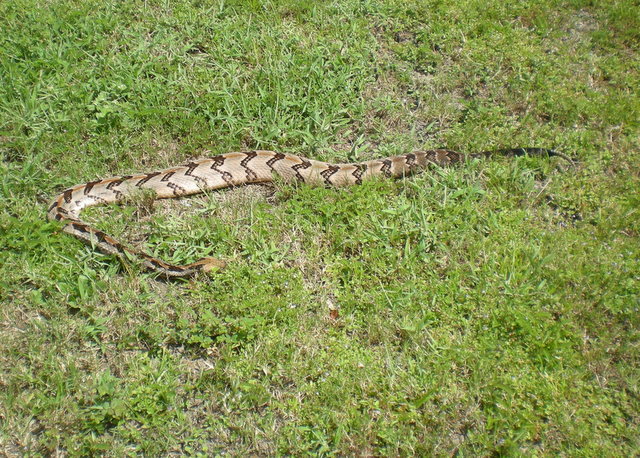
(47, 148), (573, 278)
